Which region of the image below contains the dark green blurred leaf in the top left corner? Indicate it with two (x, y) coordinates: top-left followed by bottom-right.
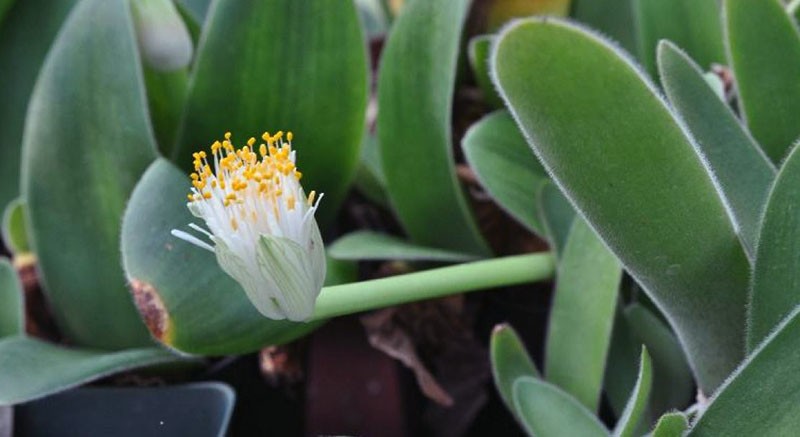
(0, 0), (76, 210)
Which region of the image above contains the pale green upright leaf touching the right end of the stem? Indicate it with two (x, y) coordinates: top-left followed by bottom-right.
(544, 218), (622, 411)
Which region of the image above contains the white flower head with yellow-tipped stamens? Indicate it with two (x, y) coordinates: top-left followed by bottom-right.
(172, 132), (325, 321)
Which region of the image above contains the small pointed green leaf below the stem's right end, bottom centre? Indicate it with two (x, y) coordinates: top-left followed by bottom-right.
(489, 324), (539, 419)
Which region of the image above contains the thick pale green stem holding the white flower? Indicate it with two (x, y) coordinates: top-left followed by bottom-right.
(312, 252), (555, 320)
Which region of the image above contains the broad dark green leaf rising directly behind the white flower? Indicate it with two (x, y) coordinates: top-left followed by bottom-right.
(172, 0), (368, 227)
